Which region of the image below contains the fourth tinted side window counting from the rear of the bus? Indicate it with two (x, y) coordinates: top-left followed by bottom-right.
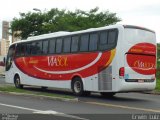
(80, 34), (89, 51)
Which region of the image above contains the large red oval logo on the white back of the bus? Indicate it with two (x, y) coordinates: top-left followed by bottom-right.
(126, 43), (156, 75)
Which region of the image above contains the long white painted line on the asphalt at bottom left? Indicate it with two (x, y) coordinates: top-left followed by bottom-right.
(0, 103), (89, 120)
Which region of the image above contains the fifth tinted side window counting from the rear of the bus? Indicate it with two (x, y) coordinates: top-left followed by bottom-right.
(71, 36), (78, 52)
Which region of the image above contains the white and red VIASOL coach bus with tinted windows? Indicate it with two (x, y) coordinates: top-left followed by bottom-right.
(6, 25), (156, 95)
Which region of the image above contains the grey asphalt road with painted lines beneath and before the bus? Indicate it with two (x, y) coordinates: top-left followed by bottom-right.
(0, 78), (160, 119)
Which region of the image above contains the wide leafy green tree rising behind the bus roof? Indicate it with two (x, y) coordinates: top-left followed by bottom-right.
(11, 7), (121, 39)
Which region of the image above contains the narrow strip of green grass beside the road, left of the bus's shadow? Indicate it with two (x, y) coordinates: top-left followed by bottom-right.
(0, 85), (75, 99)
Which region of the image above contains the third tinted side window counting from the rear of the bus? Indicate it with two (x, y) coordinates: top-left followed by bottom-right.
(89, 33), (98, 51)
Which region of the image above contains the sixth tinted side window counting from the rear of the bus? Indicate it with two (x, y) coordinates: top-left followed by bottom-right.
(63, 37), (71, 53)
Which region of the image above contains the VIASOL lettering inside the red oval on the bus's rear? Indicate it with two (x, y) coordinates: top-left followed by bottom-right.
(134, 60), (155, 69)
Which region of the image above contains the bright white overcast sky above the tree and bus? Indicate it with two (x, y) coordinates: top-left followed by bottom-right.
(0, 0), (160, 42)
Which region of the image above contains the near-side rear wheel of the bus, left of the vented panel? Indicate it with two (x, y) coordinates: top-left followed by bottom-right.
(71, 77), (84, 96)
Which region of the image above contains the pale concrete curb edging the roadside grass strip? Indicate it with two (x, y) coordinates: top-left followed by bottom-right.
(0, 91), (79, 102)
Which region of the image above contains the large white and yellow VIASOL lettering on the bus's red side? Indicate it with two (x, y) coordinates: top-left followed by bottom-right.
(48, 56), (68, 67)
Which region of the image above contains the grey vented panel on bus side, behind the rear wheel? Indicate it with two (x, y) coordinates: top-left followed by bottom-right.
(98, 66), (112, 90)
